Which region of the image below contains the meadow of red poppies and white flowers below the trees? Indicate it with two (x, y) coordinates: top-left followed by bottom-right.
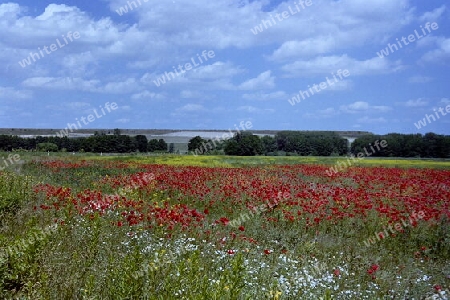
(0, 153), (450, 299)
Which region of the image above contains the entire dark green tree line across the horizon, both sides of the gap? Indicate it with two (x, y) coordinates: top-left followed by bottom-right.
(0, 129), (450, 158)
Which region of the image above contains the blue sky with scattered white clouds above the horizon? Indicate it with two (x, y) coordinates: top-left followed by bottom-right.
(0, 0), (450, 134)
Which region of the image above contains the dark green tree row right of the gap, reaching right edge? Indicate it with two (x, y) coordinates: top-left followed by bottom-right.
(188, 131), (450, 158)
